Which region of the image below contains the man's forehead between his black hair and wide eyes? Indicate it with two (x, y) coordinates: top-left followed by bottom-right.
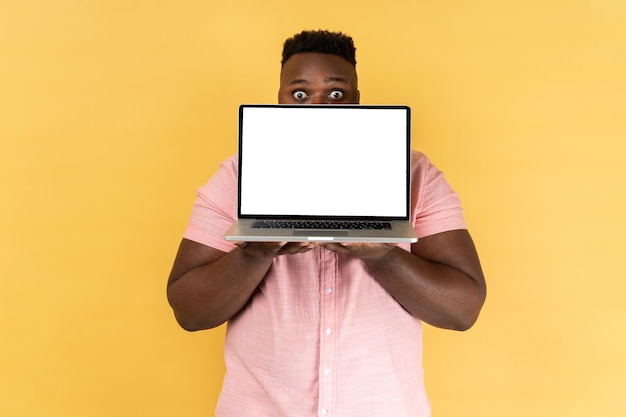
(280, 52), (356, 85)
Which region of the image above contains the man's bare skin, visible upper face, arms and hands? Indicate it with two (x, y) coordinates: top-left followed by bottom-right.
(167, 53), (486, 331)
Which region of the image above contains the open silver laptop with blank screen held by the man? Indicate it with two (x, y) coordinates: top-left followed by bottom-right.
(224, 104), (417, 243)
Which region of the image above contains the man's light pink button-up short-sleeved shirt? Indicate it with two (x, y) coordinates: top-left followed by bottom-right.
(184, 152), (466, 417)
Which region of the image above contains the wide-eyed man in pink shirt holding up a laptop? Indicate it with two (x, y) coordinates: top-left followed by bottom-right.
(168, 31), (486, 417)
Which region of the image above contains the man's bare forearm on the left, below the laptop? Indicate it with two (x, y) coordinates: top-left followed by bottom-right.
(168, 248), (274, 331)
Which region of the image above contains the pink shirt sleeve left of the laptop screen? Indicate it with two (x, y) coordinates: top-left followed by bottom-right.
(183, 155), (238, 252)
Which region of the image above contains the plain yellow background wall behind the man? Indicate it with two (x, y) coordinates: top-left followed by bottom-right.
(0, 0), (626, 417)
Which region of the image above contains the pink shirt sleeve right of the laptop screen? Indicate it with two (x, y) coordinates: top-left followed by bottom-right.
(411, 151), (467, 238)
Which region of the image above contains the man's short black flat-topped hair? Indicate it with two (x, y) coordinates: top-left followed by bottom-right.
(280, 30), (356, 67)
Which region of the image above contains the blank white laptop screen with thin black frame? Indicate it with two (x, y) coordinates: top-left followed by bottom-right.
(239, 105), (410, 219)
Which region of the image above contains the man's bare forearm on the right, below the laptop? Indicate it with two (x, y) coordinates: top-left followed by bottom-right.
(364, 247), (485, 330)
